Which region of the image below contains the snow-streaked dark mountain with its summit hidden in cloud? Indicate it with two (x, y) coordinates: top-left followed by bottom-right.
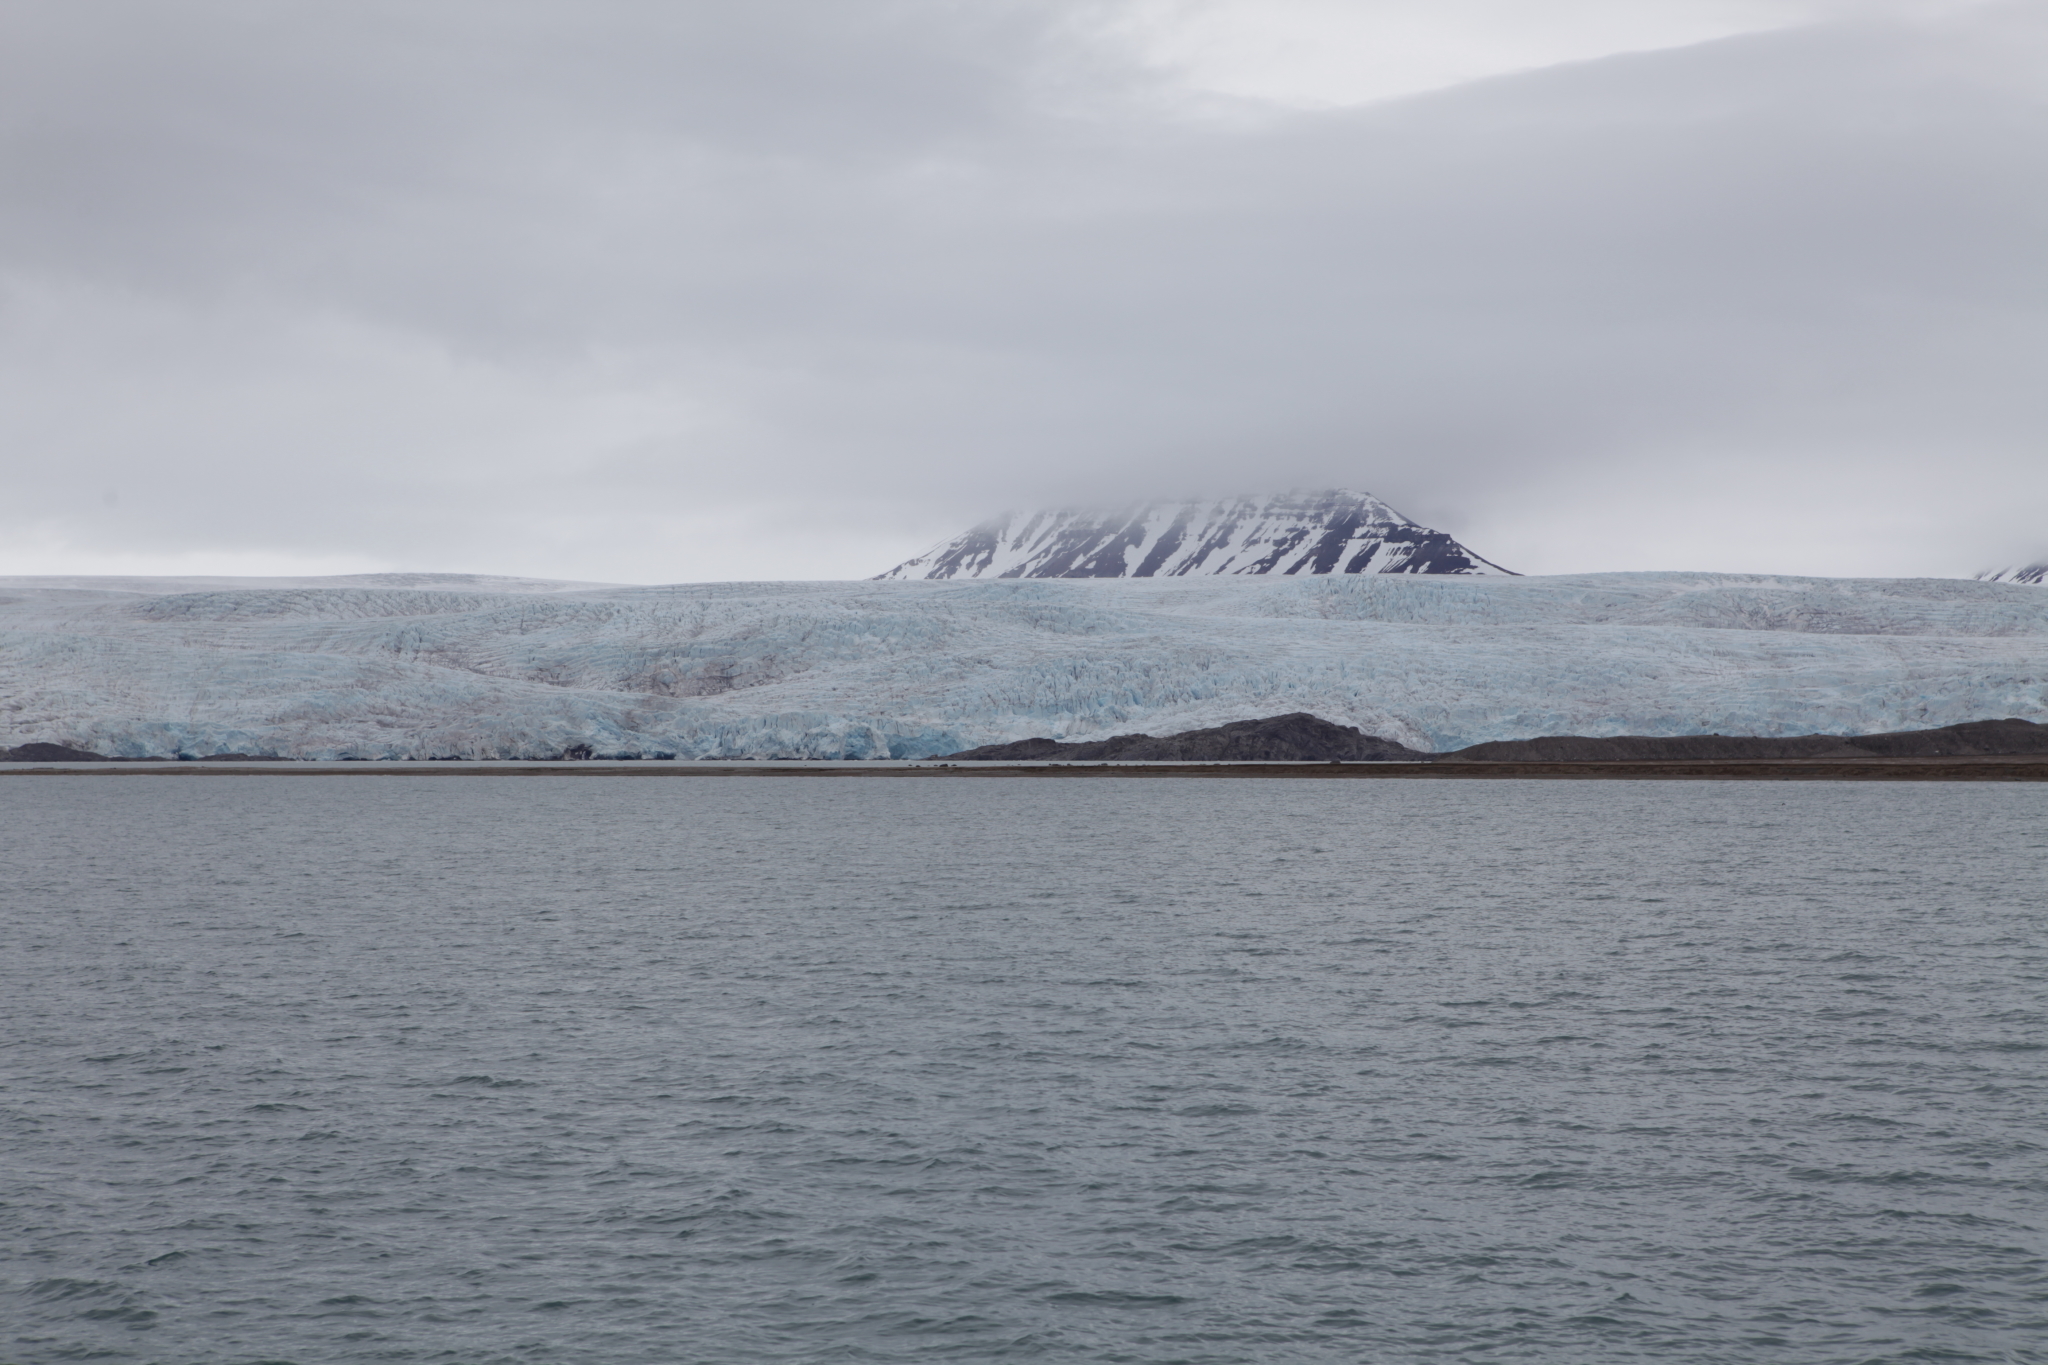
(874, 489), (1513, 579)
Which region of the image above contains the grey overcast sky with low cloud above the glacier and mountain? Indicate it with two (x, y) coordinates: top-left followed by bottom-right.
(0, 0), (2048, 581)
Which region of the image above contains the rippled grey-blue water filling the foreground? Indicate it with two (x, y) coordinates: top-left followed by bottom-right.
(0, 776), (2048, 1365)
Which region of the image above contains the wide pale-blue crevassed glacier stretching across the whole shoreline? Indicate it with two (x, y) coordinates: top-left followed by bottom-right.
(0, 573), (2048, 759)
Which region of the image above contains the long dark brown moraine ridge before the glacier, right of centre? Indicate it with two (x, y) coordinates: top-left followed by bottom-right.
(944, 710), (2048, 763)
